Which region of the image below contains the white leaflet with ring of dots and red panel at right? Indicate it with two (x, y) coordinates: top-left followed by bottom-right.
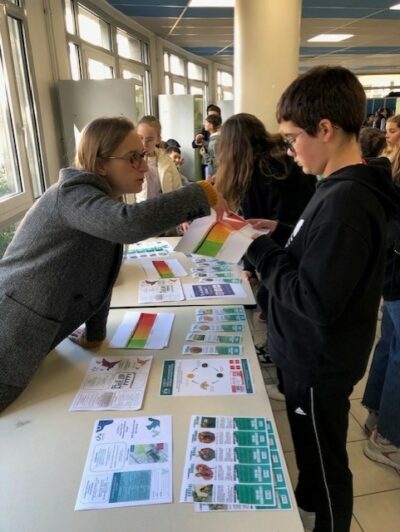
(160, 358), (254, 396)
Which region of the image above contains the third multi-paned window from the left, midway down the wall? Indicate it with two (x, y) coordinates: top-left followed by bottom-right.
(164, 51), (208, 102)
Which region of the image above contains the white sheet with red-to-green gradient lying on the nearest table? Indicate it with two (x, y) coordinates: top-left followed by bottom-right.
(110, 311), (175, 350)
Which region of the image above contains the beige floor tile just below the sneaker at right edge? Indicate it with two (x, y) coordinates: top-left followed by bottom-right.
(347, 441), (400, 496)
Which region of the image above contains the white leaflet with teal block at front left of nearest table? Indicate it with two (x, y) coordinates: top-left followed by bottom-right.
(75, 416), (172, 510)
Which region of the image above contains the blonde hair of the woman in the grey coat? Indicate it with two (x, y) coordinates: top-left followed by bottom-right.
(74, 116), (135, 174)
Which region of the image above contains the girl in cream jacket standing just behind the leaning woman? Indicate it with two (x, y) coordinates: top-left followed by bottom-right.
(135, 115), (182, 202)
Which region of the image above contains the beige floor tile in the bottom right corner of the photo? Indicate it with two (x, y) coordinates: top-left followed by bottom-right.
(353, 489), (400, 532)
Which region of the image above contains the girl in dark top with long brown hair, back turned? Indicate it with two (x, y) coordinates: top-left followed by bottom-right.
(216, 113), (316, 400)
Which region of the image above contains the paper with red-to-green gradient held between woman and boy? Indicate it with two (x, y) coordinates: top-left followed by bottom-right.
(175, 213), (268, 263)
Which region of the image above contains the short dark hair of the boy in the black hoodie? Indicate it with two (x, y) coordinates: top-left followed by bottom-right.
(276, 66), (366, 137)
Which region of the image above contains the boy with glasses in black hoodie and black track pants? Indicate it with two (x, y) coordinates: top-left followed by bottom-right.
(247, 66), (398, 532)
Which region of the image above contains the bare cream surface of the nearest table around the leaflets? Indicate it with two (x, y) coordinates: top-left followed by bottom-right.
(0, 307), (303, 532)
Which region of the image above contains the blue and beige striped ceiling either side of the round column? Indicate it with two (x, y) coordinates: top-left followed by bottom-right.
(108, 0), (400, 74)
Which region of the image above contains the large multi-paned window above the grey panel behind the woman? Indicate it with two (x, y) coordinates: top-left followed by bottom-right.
(65, 0), (152, 117)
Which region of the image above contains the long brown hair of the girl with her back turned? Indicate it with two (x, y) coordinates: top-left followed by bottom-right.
(215, 113), (288, 210)
